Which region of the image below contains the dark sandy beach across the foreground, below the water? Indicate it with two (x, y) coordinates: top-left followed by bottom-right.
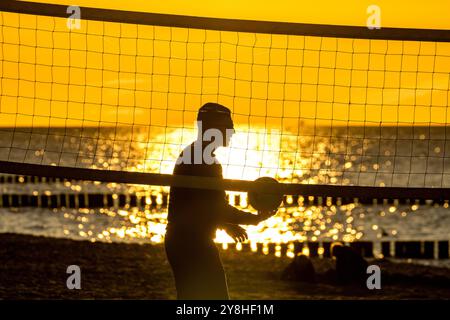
(0, 234), (450, 299)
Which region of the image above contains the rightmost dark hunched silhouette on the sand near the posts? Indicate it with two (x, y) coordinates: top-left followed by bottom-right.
(331, 243), (368, 286)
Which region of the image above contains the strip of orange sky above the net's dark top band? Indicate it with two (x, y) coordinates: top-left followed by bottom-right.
(39, 0), (450, 30)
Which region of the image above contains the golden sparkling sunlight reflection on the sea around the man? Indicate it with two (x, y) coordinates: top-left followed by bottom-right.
(45, 129), (440, 257)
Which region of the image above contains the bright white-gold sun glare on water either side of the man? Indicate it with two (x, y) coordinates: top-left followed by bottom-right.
(54, 125), (380, 257)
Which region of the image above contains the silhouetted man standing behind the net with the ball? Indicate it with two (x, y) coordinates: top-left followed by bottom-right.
(165, 103), (274, 299)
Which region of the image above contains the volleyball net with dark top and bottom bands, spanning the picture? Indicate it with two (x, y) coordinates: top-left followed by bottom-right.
(0, 0), (450, 200)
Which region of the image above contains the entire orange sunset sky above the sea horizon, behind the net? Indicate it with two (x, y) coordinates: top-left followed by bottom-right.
(0, 0), (450, 128)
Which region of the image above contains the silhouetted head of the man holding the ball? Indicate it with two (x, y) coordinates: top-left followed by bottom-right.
(197, 102), (234, 147)
